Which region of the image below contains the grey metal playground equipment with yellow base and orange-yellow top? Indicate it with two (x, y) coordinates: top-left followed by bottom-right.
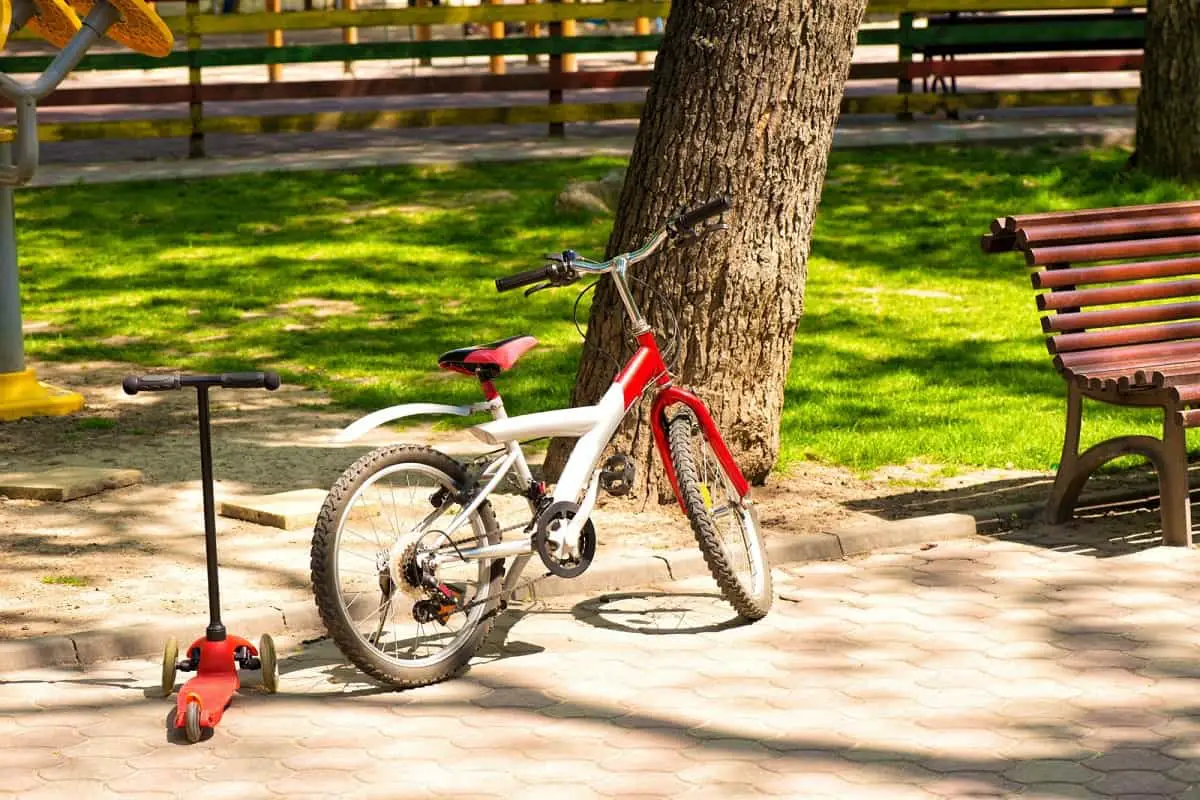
(0, 0), (174, 420)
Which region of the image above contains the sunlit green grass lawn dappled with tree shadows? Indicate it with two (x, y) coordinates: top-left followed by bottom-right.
(18, 146), (1193, 469)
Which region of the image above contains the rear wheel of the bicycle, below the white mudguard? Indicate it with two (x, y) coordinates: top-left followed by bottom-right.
(311, 445), (504, 688)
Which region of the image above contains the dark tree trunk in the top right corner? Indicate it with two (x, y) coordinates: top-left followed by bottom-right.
(1136, 0), (1200, 181)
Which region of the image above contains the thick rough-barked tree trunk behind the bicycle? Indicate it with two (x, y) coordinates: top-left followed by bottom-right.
(546, 0), (865, 497)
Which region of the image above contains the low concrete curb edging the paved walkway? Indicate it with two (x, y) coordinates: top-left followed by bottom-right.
(0, 513), (993, 672)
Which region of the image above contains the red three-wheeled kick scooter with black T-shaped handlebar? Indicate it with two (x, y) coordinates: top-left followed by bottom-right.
(121, 372), (280, 742)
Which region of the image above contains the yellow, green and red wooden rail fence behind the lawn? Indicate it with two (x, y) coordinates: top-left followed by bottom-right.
(0, 0), (1145, 155)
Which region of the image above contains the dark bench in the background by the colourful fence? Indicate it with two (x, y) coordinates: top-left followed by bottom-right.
(911, 8), (1146, 92)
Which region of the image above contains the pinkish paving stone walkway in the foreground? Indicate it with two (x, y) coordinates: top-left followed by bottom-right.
(0, 539), (1200, 800)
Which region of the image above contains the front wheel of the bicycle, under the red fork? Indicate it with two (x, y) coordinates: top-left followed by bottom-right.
(667, 411), (772, 621)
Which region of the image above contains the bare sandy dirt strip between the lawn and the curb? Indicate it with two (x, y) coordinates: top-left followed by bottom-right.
(0, 362), (1161, 639)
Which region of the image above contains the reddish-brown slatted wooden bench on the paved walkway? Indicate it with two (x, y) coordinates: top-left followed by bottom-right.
(982, 201), (1200, 546)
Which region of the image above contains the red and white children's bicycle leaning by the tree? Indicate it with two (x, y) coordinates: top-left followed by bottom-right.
(312, 198), (772, 687)
